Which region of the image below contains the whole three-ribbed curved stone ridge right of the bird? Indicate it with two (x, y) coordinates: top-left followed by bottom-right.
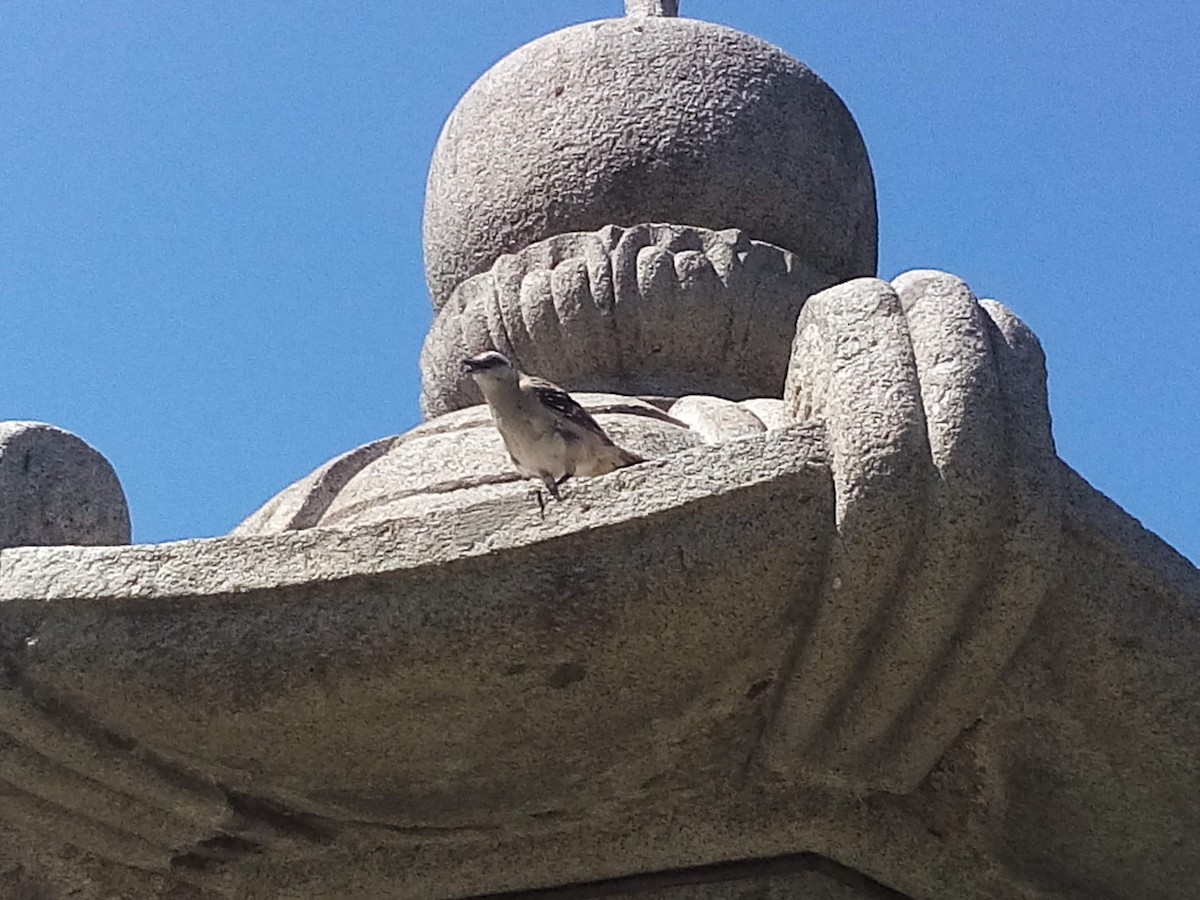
(764, 271), (1061, 792)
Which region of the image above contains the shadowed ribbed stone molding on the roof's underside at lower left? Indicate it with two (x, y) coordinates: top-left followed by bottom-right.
(0, 611), (333, 882)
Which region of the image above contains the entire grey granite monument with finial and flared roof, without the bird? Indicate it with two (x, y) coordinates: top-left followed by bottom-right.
(0, 0), (1200, 900)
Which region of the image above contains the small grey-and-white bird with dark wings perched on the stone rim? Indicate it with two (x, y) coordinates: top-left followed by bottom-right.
(462, 350), (646, 512)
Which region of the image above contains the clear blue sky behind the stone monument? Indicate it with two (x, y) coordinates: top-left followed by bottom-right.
(0, 0), (1200, 560)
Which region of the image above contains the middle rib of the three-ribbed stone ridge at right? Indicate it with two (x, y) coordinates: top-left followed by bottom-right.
(829, 272), (1012, 758)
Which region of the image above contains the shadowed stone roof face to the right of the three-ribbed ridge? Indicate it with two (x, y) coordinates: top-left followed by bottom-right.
(979, 467), (1200, 900)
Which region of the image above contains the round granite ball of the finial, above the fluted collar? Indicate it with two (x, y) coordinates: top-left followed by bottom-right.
(425, 17), (877, 310)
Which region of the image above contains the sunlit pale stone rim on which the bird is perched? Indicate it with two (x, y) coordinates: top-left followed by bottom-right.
(0, 426), (823, 602)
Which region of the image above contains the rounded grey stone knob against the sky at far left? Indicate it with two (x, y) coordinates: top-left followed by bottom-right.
(0, 421), (130, 548)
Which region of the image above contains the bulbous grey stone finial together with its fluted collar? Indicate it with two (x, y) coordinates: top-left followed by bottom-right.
(422, 14), (877, 415)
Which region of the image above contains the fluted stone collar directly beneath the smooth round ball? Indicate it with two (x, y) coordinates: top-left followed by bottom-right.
(421, 224), (835, 418)
